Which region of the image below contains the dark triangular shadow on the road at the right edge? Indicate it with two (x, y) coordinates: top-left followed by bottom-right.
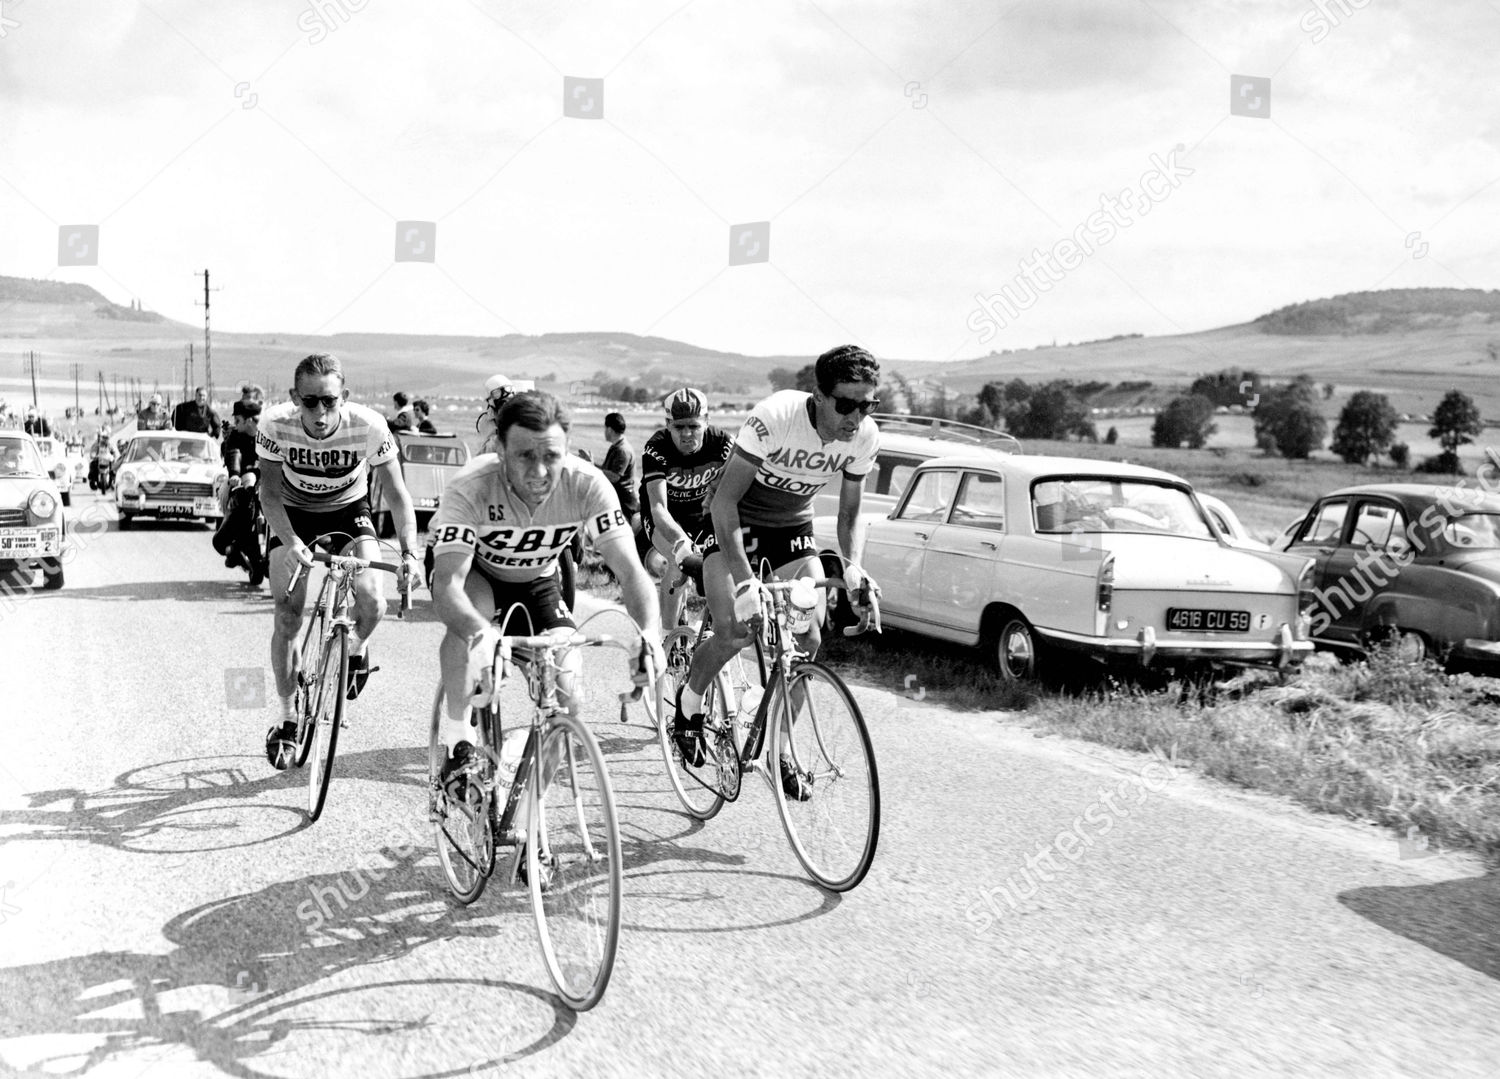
(1338, 872), (1500, 980)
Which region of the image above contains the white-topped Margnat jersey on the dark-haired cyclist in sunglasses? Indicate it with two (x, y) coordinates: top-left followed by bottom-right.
(735, 390), (881, 528)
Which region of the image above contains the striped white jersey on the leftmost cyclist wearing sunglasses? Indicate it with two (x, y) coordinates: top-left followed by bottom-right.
(255, 401), (396, 512)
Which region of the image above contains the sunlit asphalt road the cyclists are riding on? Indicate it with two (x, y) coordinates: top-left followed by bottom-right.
(0, 494), (1500, 1079)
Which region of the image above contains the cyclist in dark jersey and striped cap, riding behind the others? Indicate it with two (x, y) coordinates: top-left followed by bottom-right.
(641, 387), (734, 626)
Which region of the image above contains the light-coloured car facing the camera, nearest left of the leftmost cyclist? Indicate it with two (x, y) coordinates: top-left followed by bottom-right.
(114, 431), (225, 530)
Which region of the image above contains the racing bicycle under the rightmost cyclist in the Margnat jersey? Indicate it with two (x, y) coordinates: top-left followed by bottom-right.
(656, 578), (881, 891)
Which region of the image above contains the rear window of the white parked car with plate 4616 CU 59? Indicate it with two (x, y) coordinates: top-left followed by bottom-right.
(1032, 476), (1212, 539)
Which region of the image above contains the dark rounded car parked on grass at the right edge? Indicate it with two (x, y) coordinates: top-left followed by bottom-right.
(1286, 483), (1500, 672)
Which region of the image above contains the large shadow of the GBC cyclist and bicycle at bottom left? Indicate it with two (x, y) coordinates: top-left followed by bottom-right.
(0, 848), (576, 1079)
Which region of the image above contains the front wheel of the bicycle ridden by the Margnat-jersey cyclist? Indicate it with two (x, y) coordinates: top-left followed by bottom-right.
(771, 662), (881, 891)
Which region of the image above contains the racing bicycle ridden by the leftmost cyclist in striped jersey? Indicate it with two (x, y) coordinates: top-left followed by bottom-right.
(287, 533), (411, 822)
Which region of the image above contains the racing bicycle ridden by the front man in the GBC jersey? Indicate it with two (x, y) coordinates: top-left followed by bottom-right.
(429, 608), (654, 1011)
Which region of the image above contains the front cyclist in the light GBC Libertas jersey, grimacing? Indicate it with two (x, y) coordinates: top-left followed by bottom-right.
(432, 390), (665, 813)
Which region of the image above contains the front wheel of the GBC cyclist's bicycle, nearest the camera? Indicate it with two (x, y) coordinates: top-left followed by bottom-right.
(527, 714), (626, 1011)
